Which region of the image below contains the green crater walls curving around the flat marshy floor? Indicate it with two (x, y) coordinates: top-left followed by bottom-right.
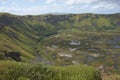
(0, 13), (120, 61)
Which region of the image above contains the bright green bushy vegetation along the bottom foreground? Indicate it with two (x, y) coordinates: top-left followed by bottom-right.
(0, 61), (101, 80)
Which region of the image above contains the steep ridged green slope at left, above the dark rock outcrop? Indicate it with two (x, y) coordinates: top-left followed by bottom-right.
(0, 14), (37, 60)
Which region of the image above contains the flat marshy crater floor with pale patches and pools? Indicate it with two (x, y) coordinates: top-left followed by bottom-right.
(39, 30), (120, 72)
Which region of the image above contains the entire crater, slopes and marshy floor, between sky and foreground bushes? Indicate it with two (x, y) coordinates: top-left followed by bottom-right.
(0, 13), (120, 73)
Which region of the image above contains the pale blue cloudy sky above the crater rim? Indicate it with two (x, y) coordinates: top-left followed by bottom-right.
(0, 0), (120, 15)
